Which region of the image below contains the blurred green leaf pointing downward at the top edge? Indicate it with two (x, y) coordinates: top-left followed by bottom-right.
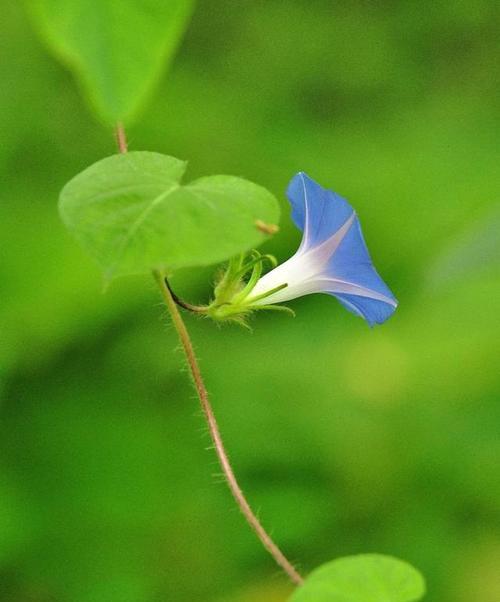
(28, 0), (193, 123)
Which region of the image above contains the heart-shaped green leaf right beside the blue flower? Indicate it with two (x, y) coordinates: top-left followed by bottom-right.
(59, 152), (279, 280)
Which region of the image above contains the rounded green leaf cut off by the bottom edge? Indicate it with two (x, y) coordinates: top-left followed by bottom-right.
(290, 554), (425, 602)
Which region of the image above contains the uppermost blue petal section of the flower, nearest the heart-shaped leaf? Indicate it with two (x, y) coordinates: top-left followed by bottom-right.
(287, 172), (354, 247)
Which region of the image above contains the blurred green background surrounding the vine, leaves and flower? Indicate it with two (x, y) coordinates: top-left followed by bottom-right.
(0, 0), (500, 602)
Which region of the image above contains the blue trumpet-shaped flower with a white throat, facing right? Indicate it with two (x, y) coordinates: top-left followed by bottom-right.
(248, 172), (397, 326)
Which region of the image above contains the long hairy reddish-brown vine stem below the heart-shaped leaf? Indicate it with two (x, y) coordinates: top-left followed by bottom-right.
(153, 270), (304, 585)
